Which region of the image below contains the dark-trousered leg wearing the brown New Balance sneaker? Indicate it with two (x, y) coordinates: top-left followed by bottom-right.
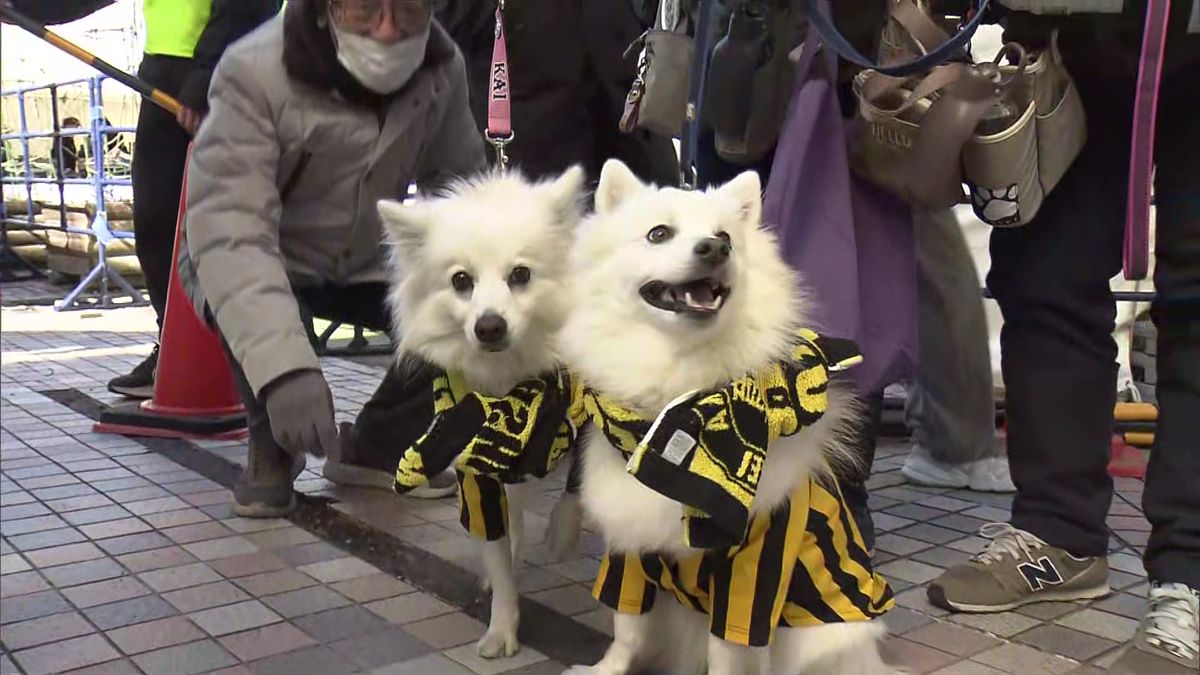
(930, 43), (1133, 611)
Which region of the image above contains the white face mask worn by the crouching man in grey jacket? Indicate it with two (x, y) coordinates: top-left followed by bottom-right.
(329, 18), (430, 94)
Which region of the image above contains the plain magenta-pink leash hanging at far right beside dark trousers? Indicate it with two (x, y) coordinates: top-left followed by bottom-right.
(1122, 0), (1171, 280)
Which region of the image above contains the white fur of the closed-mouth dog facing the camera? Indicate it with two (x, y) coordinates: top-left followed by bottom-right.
(378, 167), (583, 658)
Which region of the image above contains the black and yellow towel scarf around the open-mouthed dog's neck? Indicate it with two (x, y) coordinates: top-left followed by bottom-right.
(571, 330), (862, 548)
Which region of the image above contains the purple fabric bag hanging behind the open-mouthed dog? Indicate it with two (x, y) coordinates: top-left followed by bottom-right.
(763, 34), (917, 394)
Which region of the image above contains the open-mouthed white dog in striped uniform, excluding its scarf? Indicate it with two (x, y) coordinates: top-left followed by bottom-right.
(559, 161), (893, 675)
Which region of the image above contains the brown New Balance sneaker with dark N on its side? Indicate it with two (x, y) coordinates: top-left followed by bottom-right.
(929, 522), (1110, 613)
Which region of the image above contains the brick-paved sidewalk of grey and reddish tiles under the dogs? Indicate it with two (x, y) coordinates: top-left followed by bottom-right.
(0, 309), (1148, 675)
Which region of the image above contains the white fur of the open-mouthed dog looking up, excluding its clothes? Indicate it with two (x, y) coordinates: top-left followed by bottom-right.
(559, 160), (889, 675)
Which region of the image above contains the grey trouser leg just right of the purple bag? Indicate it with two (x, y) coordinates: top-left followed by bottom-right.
(905, 209), (1003, 464)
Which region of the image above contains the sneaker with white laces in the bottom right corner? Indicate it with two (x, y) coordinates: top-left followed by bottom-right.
(1110, 584), (1200, 675)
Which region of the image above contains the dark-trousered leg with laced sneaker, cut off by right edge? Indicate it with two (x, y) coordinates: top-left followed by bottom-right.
(1114, 55), (1200, 673)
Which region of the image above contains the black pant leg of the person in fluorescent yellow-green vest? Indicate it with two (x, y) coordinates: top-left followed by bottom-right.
(132, 55), (192, 328)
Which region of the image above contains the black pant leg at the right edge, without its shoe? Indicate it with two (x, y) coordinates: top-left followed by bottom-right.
(1142, 61), (1200, 589)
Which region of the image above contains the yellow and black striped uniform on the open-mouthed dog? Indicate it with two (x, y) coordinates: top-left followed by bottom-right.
(592, 478), (894, 646)
